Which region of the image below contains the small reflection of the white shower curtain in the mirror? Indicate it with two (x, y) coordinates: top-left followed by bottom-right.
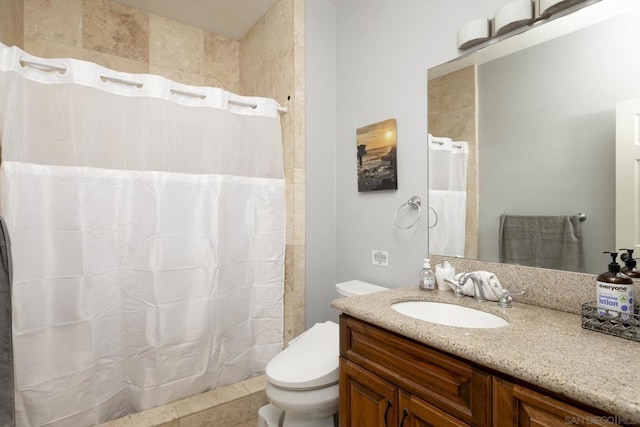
(428, 135), (469, 257)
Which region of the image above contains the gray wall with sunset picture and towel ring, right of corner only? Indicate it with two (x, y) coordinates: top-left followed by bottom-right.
(336, 0), (507, 287)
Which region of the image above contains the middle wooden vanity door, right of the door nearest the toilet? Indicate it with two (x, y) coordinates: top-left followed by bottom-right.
(399, 391), (469, 427)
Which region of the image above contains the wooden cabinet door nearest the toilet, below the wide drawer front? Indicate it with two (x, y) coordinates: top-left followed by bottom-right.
(339, 357), (398, 427)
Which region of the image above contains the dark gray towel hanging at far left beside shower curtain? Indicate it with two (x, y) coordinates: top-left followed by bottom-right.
(0, 218), (15, 426)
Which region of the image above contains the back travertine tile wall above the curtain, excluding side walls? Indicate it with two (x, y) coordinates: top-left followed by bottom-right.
(20, 0), (241, 93)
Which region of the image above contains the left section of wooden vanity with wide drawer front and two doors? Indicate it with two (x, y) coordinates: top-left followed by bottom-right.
(340, 315), (491, 427)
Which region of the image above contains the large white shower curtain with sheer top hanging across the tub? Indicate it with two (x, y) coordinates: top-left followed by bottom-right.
(0, 46), (285, 426)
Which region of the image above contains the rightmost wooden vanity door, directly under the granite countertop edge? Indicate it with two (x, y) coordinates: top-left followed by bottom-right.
(493, 377), (612, 427)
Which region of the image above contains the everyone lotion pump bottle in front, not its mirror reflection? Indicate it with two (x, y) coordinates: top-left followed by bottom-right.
(596, 252), (633, 320)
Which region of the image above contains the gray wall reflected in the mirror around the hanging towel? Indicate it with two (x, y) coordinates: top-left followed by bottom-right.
(478, 14), (640, 274)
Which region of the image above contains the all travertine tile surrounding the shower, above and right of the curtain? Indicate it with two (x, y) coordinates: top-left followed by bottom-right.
(0, 0), (305, 342)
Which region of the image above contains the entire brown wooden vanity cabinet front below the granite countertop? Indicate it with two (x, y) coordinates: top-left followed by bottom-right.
(339, 314), (624, 427)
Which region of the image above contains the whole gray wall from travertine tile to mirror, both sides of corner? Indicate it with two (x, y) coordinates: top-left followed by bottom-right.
(305, 0), (509, 326)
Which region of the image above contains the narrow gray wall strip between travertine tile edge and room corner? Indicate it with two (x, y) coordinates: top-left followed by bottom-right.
(305, 0), (337, 327)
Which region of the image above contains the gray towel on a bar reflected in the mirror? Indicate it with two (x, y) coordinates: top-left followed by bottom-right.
(499, 214), (584, 272)
